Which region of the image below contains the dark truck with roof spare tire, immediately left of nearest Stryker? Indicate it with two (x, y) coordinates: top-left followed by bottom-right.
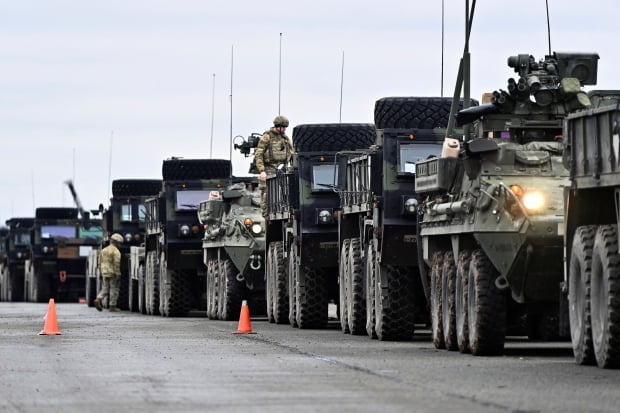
(337, 97), (458, 340)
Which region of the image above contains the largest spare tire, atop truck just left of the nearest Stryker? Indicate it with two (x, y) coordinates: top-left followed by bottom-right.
(375, 97), (478, 129)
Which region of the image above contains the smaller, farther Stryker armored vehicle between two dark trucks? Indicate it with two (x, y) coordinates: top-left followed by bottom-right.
(198, 178), (266, 320)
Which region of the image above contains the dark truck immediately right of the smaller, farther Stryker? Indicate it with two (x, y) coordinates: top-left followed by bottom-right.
(265, 123), (375, 328)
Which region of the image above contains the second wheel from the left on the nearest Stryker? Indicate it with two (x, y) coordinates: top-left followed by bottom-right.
(441, 251), (458, 351)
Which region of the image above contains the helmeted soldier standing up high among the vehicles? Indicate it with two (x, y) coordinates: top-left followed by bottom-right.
(254, 116), (293, 216)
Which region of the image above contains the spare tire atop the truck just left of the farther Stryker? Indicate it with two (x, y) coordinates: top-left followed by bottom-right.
(162, 159), (232, 181)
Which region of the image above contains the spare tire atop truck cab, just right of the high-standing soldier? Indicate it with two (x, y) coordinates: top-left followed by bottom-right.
(293, 123), (376, 152)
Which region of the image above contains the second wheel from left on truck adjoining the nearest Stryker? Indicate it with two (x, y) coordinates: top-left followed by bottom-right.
(347, 238), (366, 335)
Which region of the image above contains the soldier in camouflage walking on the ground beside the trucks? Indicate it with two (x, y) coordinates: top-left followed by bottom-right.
(94, 234), (123, 312)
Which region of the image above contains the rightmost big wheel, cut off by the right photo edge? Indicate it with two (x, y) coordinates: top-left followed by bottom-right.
(590, 224), (620, 368)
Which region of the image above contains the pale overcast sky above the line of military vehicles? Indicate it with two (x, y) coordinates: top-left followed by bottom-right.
(0, 0), (620, 223)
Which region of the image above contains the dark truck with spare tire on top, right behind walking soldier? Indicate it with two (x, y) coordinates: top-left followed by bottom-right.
(86, 179), (161, 311)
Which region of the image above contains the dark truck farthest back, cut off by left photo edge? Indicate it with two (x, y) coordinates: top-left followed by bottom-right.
(0, 218), (34, 301)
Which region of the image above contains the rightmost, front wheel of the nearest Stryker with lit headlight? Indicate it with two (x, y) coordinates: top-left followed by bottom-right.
(467, 250), (506, 356)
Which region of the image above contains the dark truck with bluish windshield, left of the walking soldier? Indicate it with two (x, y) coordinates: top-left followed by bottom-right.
(24, 207), (103, 302)
